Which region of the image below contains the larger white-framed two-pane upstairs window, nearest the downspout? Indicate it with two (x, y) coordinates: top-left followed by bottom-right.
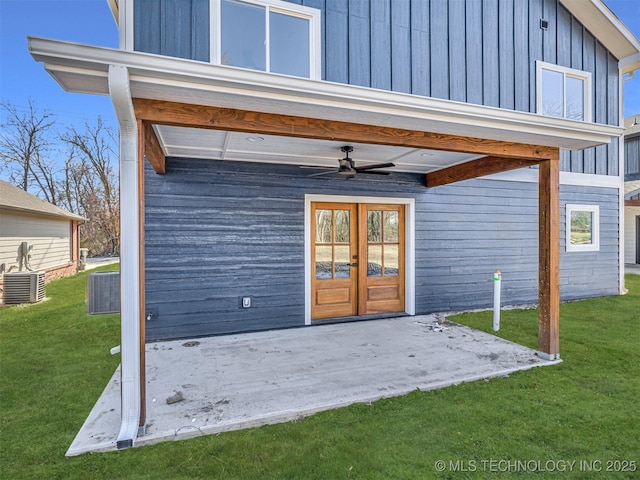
(211, 0), (321, 79)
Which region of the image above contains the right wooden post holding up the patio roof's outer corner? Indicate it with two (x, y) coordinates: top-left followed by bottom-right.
(538, 151), (560, 360)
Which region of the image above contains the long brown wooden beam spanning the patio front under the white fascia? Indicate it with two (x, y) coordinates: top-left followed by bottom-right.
(133, 98), (557, 160)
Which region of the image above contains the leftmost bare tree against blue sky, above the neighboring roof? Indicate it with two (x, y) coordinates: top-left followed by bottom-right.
(0, 99), (57, 196)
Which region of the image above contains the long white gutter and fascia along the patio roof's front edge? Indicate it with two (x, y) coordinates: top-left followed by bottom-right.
(28, 37), (623, 149)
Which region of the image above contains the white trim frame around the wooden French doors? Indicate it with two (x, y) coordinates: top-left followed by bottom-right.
(304, 194), (415, 325)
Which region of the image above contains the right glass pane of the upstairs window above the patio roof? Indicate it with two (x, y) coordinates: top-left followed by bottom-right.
(269, 12), (311, 78)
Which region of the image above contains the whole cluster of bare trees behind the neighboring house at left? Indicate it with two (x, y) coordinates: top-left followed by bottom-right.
(0, 100), (120, 255)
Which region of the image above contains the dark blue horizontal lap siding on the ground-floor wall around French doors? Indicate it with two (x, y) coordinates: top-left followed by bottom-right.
(145, 158), (618, 341)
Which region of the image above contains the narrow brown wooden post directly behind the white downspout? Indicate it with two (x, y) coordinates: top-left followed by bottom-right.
(137, 120), (147, 427)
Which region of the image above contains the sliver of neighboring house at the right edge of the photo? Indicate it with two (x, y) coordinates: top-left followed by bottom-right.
(624, 115), (640, 264)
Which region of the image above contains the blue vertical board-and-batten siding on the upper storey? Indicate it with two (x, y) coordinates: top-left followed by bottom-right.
(134, 0), (620, 175)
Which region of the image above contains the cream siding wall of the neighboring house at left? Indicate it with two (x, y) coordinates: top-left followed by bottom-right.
(0, 210), (72, 271)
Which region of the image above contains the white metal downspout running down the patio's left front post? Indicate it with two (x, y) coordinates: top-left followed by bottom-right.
(109, 65), (140, 449)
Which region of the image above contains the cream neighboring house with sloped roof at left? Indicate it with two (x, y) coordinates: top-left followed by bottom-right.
(0, 180), (85, 294)
